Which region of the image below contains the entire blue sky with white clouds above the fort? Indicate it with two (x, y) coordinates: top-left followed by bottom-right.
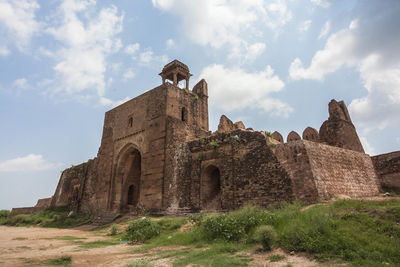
(0, 0), (400, 209)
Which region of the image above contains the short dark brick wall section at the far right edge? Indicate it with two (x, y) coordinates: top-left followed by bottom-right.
(371, 151), (400, 194)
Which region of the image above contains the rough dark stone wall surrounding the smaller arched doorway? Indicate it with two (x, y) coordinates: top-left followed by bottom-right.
(167, 130), (293, 214)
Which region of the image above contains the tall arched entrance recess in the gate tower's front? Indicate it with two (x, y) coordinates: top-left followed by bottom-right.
(113, 146), (142, 213)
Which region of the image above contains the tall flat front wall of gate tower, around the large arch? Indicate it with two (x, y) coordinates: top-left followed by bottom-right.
(96, 85), (167, 213)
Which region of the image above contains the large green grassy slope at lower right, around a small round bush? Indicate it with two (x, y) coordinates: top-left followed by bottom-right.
(125, 200), (400, 266)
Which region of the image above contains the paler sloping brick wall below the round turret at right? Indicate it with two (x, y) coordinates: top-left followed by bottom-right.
(302, 141), (379, 199)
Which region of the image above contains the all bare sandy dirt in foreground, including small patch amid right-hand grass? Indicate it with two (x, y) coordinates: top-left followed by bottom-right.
(0, 226), (318, 267)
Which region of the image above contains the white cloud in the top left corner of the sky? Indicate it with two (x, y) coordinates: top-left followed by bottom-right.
(0, 0), (40, 50)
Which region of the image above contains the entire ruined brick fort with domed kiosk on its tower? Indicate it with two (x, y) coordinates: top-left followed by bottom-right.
(13, 60), (400, 220)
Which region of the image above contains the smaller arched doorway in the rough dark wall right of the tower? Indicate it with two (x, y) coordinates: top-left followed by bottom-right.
(201, 165), (221, 210)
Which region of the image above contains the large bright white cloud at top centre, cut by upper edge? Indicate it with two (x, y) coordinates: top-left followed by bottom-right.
(152, 0), (292, 61)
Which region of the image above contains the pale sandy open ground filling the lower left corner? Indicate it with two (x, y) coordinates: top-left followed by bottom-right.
(0, 226), (148, 266)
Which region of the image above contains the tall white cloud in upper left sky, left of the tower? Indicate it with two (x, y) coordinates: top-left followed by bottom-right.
(47, 0), (123, 97)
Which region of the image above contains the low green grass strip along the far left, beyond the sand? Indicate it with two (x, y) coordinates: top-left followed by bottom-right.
(0, 208), (91, 228)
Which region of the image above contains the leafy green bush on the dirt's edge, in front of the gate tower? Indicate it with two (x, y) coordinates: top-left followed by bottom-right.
(125, 218), (161, 243)
